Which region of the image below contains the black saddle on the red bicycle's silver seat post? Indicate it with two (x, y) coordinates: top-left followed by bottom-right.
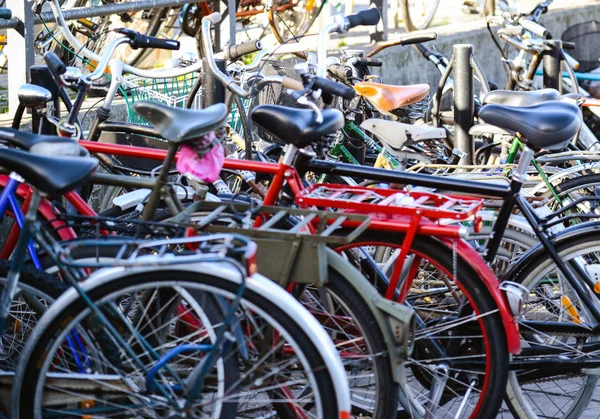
(250, 105), (344, 148)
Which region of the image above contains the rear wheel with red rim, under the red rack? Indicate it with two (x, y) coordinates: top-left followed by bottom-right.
(337, 231), (508, 418)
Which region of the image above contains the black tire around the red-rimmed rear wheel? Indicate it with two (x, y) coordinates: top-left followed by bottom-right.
(338, 231), (509, 419)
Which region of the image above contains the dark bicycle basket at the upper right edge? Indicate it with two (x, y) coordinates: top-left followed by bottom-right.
(562, 20), (600, 73)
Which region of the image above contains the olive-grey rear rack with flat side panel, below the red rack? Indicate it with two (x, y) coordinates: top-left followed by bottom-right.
(186, 201), (371, 287)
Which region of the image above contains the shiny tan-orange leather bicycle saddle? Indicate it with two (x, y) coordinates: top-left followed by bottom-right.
(354, 82), (429, 112)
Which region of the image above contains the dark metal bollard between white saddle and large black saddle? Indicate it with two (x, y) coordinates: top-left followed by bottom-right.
(452, 44), (475, 164)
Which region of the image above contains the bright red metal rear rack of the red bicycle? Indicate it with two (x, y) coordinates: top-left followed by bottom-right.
(296, 184), (483, 221)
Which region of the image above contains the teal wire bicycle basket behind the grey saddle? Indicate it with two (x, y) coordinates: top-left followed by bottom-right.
(121, 73), (202, 125)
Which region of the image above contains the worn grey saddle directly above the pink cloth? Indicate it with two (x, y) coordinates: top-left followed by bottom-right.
(133, 100), (228, 143)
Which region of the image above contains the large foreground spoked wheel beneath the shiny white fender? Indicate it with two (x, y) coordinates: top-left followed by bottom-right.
(13, 270), (338, 418)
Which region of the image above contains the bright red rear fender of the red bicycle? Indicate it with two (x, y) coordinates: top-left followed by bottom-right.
(439, 238), (521, 355)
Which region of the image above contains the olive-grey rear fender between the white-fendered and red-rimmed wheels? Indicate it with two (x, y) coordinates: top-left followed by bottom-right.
(327, 248), (414, 384)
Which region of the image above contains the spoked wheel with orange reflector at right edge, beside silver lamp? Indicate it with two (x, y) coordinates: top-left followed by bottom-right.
(506, 231), (600, 419)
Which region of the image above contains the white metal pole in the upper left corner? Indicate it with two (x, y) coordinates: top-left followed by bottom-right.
(6, 0), (35, 115)
